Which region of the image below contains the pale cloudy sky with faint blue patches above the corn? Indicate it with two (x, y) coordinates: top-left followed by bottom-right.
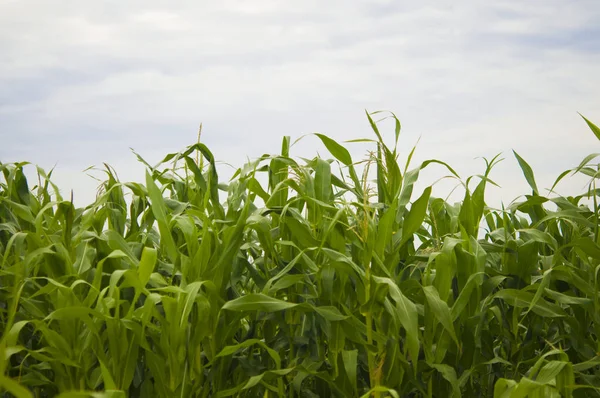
(0, 0), (600, 205)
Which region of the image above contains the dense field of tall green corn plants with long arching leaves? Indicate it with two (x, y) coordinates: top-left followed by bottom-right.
(0, 114), (600, 398)
